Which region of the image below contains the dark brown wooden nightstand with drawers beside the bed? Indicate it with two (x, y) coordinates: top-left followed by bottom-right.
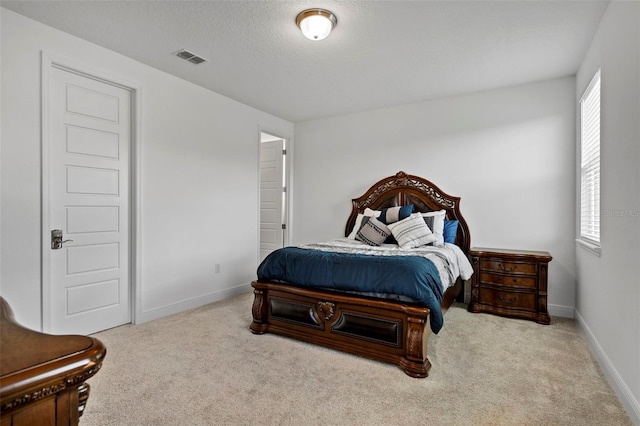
(469, 247), (552, 324)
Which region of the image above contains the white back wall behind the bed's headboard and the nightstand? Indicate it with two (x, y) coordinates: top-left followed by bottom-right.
(294, 77), (575, 316)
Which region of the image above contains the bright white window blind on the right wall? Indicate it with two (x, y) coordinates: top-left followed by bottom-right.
(580, 70), (600, 245)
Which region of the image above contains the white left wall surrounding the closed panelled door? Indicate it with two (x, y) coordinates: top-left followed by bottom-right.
(0, 8), (293, 329)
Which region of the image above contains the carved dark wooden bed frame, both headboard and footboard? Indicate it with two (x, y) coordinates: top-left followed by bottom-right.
(250, 172), (470, 378)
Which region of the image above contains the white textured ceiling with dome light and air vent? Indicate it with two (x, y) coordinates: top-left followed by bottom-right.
(1, 0), (608, 122)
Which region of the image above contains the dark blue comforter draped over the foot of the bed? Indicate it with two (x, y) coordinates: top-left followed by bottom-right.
(258, 247), (443, 333)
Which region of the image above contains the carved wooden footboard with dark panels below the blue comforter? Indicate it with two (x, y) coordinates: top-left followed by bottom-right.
(250, 281), (462, 378)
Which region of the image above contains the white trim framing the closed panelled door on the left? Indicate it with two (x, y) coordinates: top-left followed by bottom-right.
(40, 50), (142, 331)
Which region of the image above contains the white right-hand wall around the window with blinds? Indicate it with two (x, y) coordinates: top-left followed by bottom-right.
(576, 2), (640, 424)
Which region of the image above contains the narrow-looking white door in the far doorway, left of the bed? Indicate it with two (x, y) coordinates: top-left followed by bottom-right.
(260, 139), (284, 261)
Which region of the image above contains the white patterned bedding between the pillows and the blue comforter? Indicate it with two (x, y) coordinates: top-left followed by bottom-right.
(298, 238), (473, 292)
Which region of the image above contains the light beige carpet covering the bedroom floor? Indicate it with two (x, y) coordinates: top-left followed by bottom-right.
(80, 294), (631, 426)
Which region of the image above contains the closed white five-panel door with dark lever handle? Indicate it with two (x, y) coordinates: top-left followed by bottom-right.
(43, 66), (131, 334)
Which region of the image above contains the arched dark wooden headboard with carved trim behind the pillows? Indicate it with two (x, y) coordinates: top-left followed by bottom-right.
(344, 172), (471, 253)
